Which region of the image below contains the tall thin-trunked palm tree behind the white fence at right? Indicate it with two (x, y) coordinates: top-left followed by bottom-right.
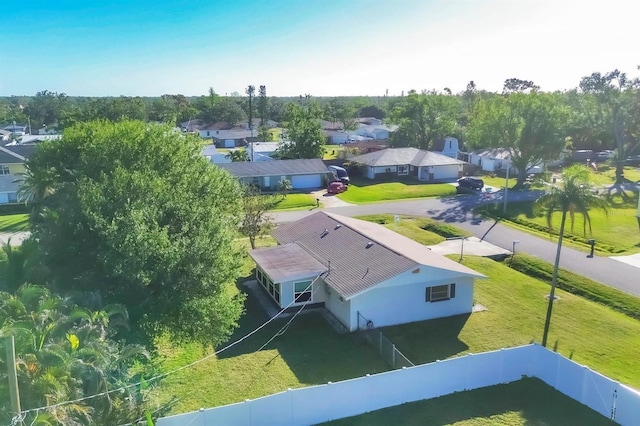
(537, 165), (608, 346)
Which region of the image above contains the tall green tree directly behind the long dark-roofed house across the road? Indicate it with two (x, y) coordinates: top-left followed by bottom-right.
(278, 96), (326, 159)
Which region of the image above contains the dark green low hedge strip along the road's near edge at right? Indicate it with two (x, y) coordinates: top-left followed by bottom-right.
(503, 253), (640, 320)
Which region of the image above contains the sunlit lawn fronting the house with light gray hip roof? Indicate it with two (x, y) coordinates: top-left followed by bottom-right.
(338, 178), (456, 204)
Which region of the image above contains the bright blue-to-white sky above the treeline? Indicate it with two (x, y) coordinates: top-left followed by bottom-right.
(0, 0), (640, 96)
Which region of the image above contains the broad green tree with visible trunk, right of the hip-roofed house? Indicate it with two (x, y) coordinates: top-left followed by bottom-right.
(467, 91), (568, 185)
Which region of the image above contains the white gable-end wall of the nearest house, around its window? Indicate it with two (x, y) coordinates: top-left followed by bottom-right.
(349, 266), (473, 331)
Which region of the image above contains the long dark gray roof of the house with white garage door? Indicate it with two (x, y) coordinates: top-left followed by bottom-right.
(217, 159), (330, 177)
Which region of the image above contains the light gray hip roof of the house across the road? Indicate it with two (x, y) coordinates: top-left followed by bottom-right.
(349, 148), (465, 167)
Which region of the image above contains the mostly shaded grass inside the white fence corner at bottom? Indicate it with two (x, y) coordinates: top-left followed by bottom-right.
(323, 379), (616, 426)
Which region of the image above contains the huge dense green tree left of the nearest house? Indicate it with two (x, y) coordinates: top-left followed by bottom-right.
(27, 121), (242, 344)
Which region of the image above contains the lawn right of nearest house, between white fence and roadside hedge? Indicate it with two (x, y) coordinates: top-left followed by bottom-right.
(383, 256), (640, 388)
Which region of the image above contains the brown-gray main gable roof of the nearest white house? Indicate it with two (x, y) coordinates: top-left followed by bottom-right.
(272, 212), (482, 299)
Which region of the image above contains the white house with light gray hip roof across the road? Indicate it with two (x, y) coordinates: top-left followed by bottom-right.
(348, 148), (465, 182)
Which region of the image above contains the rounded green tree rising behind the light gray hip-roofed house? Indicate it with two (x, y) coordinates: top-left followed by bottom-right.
(389, 90), (460, 150)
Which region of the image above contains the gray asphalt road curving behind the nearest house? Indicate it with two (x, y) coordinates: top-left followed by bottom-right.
(273, 191), (640, 297)
